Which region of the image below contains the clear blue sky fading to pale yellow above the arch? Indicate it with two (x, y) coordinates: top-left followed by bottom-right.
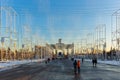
(0, 0), (120, 48)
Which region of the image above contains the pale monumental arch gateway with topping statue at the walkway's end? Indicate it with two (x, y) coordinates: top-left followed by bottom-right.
(50, 39), (74, 57)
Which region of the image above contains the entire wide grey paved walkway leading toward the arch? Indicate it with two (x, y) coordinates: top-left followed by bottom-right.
(0, 60), (120, 80)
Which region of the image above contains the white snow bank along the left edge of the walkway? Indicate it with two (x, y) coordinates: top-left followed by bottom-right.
(0, 59), (45, 71)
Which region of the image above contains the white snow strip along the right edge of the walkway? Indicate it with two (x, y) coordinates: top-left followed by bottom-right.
(77, 59), (120, 66)
